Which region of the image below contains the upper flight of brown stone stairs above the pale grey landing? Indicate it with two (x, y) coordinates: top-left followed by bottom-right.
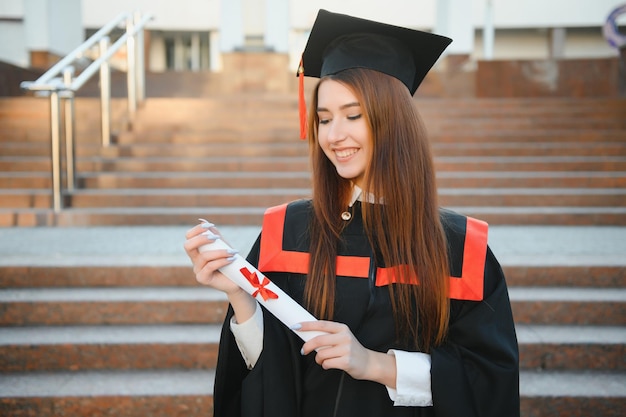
(0, 94), (626, 226)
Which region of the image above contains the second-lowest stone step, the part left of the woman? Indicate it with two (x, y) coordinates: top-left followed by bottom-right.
(0, 324), (221, 372)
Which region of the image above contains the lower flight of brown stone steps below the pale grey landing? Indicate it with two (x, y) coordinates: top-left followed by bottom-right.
(0, 250), (626, 417)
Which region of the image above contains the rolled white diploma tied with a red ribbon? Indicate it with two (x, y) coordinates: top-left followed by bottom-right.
(199, 239), (325, 342)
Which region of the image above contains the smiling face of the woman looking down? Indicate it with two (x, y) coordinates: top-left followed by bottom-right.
(317, 79), (373, 187)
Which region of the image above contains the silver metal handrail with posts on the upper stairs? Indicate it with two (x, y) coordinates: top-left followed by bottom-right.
(20, 11), (153, 212)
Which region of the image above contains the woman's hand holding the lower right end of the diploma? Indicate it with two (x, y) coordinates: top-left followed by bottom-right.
(299, 320), (396, 387)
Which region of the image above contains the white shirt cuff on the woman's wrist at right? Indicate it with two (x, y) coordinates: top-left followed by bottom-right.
(387, 349), (433, 407)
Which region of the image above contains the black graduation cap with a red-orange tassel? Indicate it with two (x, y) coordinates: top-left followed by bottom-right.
(298, 10), (452, 138)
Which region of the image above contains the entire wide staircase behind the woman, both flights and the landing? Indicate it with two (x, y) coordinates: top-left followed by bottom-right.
(0, 95), (626, 417)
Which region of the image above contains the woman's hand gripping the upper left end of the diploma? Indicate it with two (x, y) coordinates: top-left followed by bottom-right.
(184, 220), (243, 297)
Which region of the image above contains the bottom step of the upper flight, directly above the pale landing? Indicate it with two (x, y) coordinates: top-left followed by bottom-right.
(0, 204), (626, 227)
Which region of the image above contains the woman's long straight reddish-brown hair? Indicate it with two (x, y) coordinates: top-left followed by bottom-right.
(305, 69), (449, 352)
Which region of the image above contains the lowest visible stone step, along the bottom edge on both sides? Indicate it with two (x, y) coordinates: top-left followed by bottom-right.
(0, 370), (626, 417)
